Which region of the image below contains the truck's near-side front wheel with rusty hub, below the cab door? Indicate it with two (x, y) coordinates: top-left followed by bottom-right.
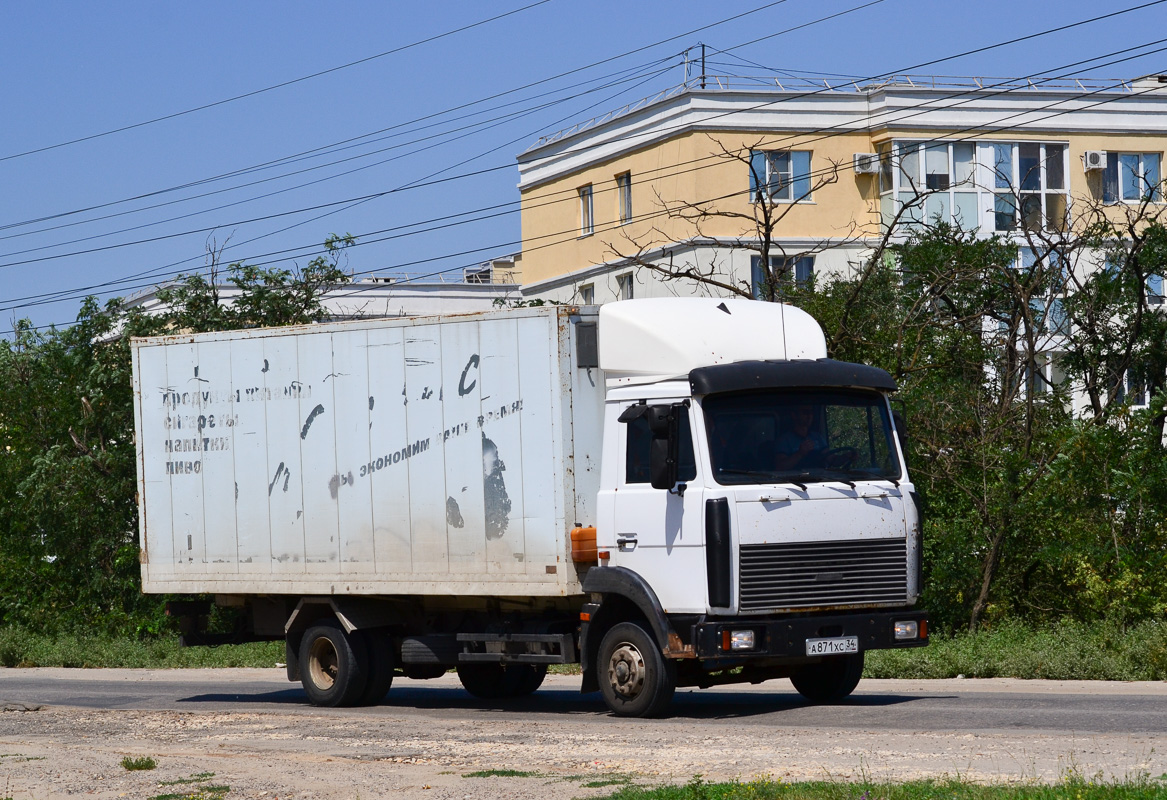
(596, 623), (677, 717)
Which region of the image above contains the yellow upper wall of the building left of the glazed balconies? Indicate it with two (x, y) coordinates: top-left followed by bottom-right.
(522, 132), (878, 282)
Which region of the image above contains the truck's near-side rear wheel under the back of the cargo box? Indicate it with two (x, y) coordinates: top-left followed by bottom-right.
(300, 623), (369, 708)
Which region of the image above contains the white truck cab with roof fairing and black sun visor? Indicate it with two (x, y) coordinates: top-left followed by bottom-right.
(581, 299), (927, 716)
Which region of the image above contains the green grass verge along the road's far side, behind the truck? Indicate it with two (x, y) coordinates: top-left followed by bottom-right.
(0, 620), (1167, 681)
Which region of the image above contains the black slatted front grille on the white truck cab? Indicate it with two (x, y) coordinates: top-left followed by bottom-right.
(739, 539), (908, 611)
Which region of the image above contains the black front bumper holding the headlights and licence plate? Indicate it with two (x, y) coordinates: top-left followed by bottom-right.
(693, 611), (928, 661)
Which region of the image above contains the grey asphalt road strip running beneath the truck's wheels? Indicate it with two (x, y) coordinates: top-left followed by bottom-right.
(0, 669), (1167, 735)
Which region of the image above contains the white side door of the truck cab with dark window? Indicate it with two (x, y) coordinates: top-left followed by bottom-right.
(609, 401), (707, 613)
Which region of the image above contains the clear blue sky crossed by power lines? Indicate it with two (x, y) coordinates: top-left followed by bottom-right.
(0, 0), (1167, 331)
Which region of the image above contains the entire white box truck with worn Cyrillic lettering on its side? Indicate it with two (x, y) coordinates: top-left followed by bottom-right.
(133, 299), (928, 716)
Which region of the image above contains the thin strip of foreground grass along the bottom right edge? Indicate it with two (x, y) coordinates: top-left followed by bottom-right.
(606, 776), (1167, 800)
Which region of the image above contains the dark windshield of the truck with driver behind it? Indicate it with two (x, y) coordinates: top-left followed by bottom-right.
(701, 388), (900, 484)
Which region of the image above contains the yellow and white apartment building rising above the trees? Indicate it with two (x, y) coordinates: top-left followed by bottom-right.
(516, 76), (1167, 303)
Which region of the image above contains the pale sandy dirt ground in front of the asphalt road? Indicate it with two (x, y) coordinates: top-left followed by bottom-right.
(0, 676), (1167, 800)
